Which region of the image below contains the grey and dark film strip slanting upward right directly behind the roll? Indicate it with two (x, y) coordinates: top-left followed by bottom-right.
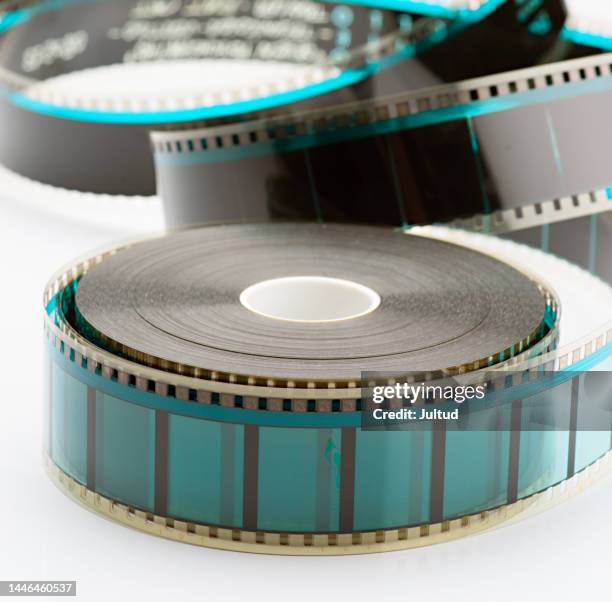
(152, 54), (612, 281)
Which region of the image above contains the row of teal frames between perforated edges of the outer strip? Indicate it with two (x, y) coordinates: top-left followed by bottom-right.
(46, 314), (610, 544)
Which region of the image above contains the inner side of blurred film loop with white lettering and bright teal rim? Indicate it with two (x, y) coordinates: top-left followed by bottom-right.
(3, 0), (430, 119)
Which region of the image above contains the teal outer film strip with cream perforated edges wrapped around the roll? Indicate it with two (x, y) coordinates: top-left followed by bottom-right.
(45, 223), (612, 553)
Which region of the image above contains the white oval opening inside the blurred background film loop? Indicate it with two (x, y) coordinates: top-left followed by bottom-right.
(26, 59), (338, 111)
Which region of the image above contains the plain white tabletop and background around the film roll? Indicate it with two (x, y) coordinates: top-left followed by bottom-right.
(0, 0), (612, 602)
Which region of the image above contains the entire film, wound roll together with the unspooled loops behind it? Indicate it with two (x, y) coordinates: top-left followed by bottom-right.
(15, 0), (612, 554)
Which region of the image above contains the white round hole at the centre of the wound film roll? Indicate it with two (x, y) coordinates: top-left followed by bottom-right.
(240, 276), (380, 322)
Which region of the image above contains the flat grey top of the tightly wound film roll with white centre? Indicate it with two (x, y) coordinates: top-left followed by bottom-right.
(71, 224), (556, 382)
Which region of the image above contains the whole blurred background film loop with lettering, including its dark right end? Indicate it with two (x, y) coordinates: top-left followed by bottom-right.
(0, 0), (565, 195)
